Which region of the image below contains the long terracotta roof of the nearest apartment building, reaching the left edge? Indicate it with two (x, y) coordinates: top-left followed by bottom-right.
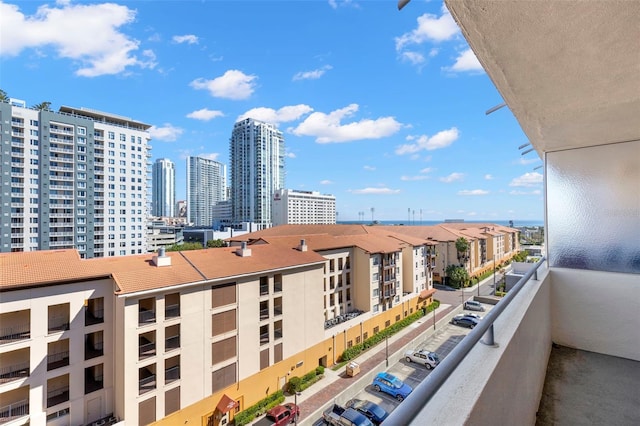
(0, 245), (325, 294)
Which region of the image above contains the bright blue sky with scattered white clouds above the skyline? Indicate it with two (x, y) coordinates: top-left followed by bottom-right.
(0, 0), (543, 224)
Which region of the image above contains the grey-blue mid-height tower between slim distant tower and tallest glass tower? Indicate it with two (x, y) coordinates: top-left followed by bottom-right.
(187, 157), (227, 227)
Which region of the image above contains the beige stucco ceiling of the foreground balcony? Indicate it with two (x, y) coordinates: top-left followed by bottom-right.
(446, 0), (640, 154)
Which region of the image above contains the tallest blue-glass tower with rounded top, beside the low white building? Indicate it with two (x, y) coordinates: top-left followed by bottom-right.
(229, 118), (285, 229)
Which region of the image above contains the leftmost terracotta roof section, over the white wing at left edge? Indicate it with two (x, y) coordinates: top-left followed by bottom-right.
(0, 249), (109, 290)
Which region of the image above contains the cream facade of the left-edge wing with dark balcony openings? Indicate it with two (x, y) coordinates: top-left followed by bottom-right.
(0, 279), (114, 425)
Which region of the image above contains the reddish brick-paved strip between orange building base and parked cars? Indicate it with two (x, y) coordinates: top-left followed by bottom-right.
(262, 305), (455, 423)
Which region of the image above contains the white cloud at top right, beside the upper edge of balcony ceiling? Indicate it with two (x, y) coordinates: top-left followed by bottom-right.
(396, 4), (460, 52)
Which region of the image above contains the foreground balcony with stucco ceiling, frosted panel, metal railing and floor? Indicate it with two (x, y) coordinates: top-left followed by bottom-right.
(385, 0), (640, 425)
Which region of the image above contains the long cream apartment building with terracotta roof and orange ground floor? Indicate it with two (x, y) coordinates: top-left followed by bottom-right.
(0, 226), (438, 425)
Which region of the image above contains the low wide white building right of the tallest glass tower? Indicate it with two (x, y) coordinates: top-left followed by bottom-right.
(272, 189), (336, 226)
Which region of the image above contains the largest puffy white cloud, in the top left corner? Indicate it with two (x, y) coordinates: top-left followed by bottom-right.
(0, 2), (156, 77)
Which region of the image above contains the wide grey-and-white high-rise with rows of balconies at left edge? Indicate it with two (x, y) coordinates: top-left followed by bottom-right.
(0, 99), (151, 258)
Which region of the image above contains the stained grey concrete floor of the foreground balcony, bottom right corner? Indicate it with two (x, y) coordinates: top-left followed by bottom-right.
(536, 344), (640, 425)
